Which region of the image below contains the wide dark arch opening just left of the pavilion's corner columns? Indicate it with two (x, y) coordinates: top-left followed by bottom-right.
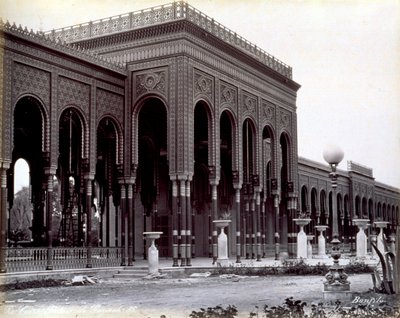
(136, 97), (172, 256)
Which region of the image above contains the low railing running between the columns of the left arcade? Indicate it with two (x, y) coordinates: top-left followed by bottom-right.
(5, 247), (122, 273)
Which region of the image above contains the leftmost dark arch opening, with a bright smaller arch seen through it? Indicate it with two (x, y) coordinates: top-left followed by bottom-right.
(8, 96), (50, 246)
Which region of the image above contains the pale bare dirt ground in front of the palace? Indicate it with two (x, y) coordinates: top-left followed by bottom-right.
(0, 274), (394, 318)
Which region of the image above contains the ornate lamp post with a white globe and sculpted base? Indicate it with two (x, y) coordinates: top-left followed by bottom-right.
(323, 145), (351, 300)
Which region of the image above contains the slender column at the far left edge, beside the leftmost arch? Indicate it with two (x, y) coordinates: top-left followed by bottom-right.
(0, 163), (9, 273)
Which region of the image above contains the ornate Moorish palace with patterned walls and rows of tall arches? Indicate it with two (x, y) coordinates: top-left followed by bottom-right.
(0, 1), (400, 271)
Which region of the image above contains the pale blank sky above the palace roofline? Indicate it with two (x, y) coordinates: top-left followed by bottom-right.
(0, 0), (400, 188)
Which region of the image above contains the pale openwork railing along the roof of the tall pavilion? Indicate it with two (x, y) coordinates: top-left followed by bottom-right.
(45, 1), (292, 79)
